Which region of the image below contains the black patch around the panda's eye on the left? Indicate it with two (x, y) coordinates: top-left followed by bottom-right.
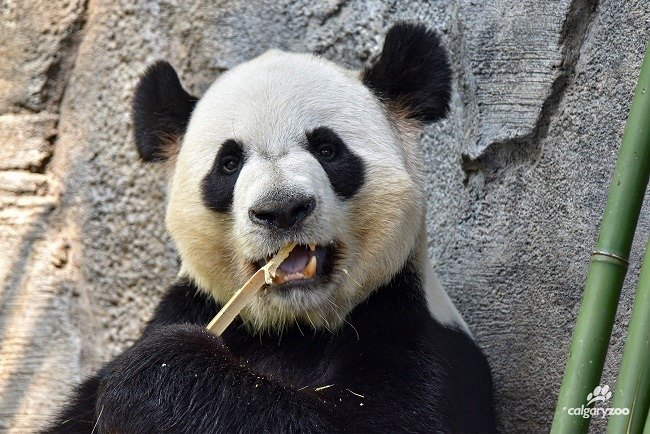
(201, 139), (245, 212)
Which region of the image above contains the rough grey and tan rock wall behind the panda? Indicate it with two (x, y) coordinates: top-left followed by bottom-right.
(0, 0), (650, 432)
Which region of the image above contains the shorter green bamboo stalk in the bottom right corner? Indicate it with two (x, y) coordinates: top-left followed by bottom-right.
(607, 239), (650, 434)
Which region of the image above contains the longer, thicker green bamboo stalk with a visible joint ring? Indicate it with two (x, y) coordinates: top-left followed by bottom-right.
(551, 47), (650, 434)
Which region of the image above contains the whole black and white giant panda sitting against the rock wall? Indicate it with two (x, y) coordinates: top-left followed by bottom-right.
(44, 23), (496, 433)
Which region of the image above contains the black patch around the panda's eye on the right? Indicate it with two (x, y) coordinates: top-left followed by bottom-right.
(307, 127), (366, 199)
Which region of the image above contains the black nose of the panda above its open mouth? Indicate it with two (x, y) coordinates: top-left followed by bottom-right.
(248, 197), (316, 229)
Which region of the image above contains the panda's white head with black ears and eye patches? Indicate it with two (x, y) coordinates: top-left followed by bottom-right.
(134, 24), (451, 330)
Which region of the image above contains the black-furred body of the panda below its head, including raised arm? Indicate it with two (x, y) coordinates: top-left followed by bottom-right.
(43, 265), (495, 433)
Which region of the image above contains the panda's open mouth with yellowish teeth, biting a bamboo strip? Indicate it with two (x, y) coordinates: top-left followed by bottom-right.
(254, 244), (335, 285)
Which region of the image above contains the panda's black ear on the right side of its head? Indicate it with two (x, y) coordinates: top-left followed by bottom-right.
(362, 23), (451, 122)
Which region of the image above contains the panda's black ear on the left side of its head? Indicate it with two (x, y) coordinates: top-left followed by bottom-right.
(133, 61), (197, 161)
